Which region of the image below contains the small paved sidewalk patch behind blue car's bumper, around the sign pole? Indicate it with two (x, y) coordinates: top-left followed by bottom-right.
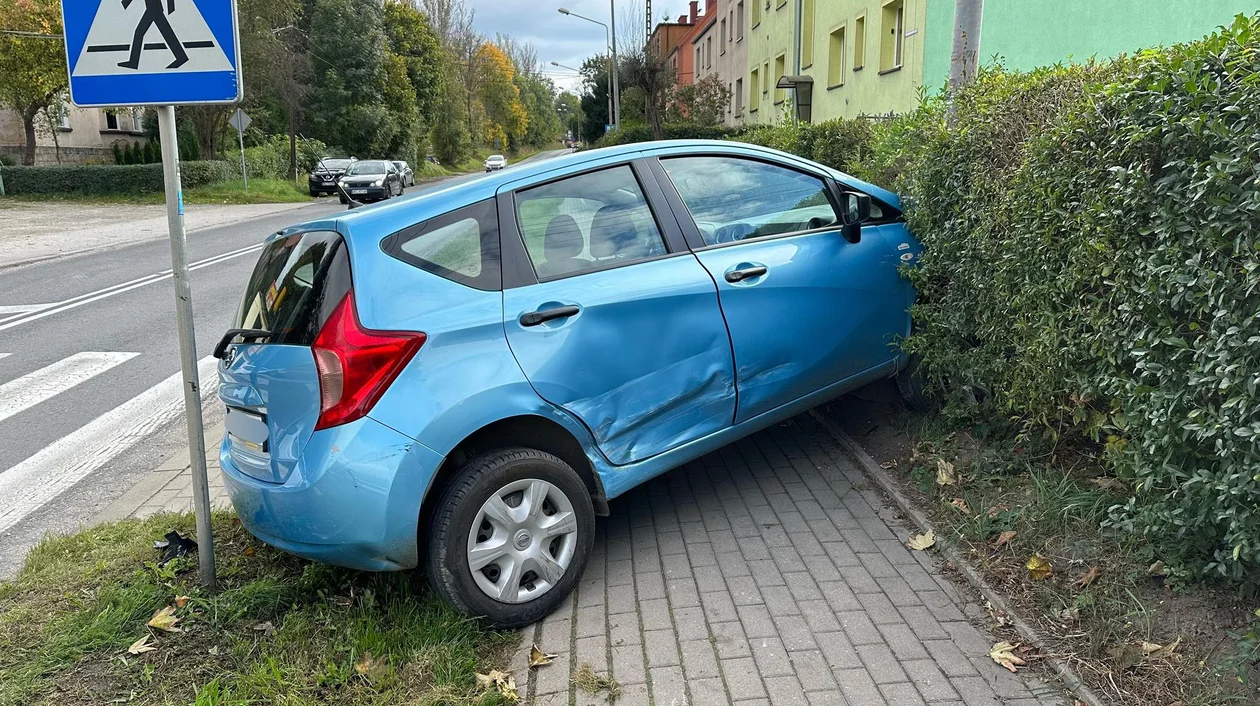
(96, 422), (232, 522)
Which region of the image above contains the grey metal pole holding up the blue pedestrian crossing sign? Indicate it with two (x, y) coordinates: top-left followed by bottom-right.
(158, 106), (215, 587)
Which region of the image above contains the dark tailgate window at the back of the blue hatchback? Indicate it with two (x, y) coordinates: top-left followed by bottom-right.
(236, 231), (350, 345)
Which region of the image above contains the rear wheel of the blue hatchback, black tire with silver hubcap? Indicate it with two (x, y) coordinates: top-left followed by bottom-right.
(426, 448), (595, 628)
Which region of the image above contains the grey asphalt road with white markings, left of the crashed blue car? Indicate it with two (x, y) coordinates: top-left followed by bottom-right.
(0, 150), (567, 579)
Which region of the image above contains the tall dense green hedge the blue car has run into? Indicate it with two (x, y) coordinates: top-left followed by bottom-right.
(882, 15), (1260, 585)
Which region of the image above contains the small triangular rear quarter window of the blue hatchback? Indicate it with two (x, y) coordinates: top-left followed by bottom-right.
(382, 198), (503, 291)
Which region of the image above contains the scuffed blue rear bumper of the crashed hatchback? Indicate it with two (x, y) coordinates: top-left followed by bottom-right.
(219, 417), (442, 571)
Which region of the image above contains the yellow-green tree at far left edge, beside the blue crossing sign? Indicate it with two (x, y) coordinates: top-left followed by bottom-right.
(0, 0), (67, 164)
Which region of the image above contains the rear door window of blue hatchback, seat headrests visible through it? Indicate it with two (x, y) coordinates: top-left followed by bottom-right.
(517, 165), (665, 279)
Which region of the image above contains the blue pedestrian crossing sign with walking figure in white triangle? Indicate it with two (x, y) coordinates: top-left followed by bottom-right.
(62, 0), (241, 107)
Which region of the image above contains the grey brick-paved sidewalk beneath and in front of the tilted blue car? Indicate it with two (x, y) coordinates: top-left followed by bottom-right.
(514, 416), (1068, 706)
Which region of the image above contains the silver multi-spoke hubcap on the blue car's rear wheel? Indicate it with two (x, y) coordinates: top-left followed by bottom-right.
(467, 478), (577, 603)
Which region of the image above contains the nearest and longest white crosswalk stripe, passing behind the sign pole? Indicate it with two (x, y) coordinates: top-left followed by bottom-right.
(0, 356), (219, 533)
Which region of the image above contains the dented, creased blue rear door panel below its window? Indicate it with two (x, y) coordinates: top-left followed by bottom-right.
(503, 253), (735, 465)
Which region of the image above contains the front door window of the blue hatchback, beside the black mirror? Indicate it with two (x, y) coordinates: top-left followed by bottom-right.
(660, 155), (838, 245)
